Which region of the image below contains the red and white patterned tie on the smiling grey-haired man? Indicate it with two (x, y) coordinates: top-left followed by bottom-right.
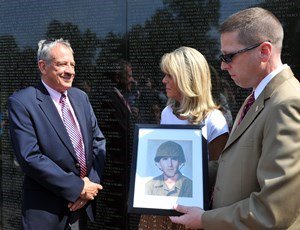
(59, 94), (87, 178)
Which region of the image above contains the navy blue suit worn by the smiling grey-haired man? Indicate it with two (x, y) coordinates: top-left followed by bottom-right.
(9, 82), (105, 229)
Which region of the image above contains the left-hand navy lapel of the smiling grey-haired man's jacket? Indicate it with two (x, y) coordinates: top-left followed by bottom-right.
(36, 83), (76, 158)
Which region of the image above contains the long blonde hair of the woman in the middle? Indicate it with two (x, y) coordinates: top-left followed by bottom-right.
(160, 47), (217, 124)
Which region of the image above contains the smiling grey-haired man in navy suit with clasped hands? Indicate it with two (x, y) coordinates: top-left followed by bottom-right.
(8, 39), (105, 230)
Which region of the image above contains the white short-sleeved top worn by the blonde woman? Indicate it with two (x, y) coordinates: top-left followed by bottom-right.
(160, 105), (229, 142)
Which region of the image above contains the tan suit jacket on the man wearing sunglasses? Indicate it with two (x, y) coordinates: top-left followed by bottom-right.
(202, 68), (300, 229)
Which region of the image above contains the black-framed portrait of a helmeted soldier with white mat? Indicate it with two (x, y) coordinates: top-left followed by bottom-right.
(128, 124), (208, 215)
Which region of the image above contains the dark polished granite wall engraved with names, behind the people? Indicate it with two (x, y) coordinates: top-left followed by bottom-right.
(0, 0), (300, 229)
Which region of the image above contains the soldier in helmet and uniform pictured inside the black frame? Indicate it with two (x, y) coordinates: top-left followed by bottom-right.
(145, 141), (193, 197)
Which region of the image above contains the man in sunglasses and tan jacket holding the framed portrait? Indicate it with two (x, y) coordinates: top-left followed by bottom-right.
(171, 7), (300, 229)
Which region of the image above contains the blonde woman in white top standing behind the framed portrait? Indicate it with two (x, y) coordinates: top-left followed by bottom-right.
(139, 47), (228, 230)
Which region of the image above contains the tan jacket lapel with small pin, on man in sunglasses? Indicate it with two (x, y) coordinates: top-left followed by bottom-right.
(223, 68), (293, 151)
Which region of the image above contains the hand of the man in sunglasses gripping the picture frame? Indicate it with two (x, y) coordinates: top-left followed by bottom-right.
(170, 205), (204, 229)
